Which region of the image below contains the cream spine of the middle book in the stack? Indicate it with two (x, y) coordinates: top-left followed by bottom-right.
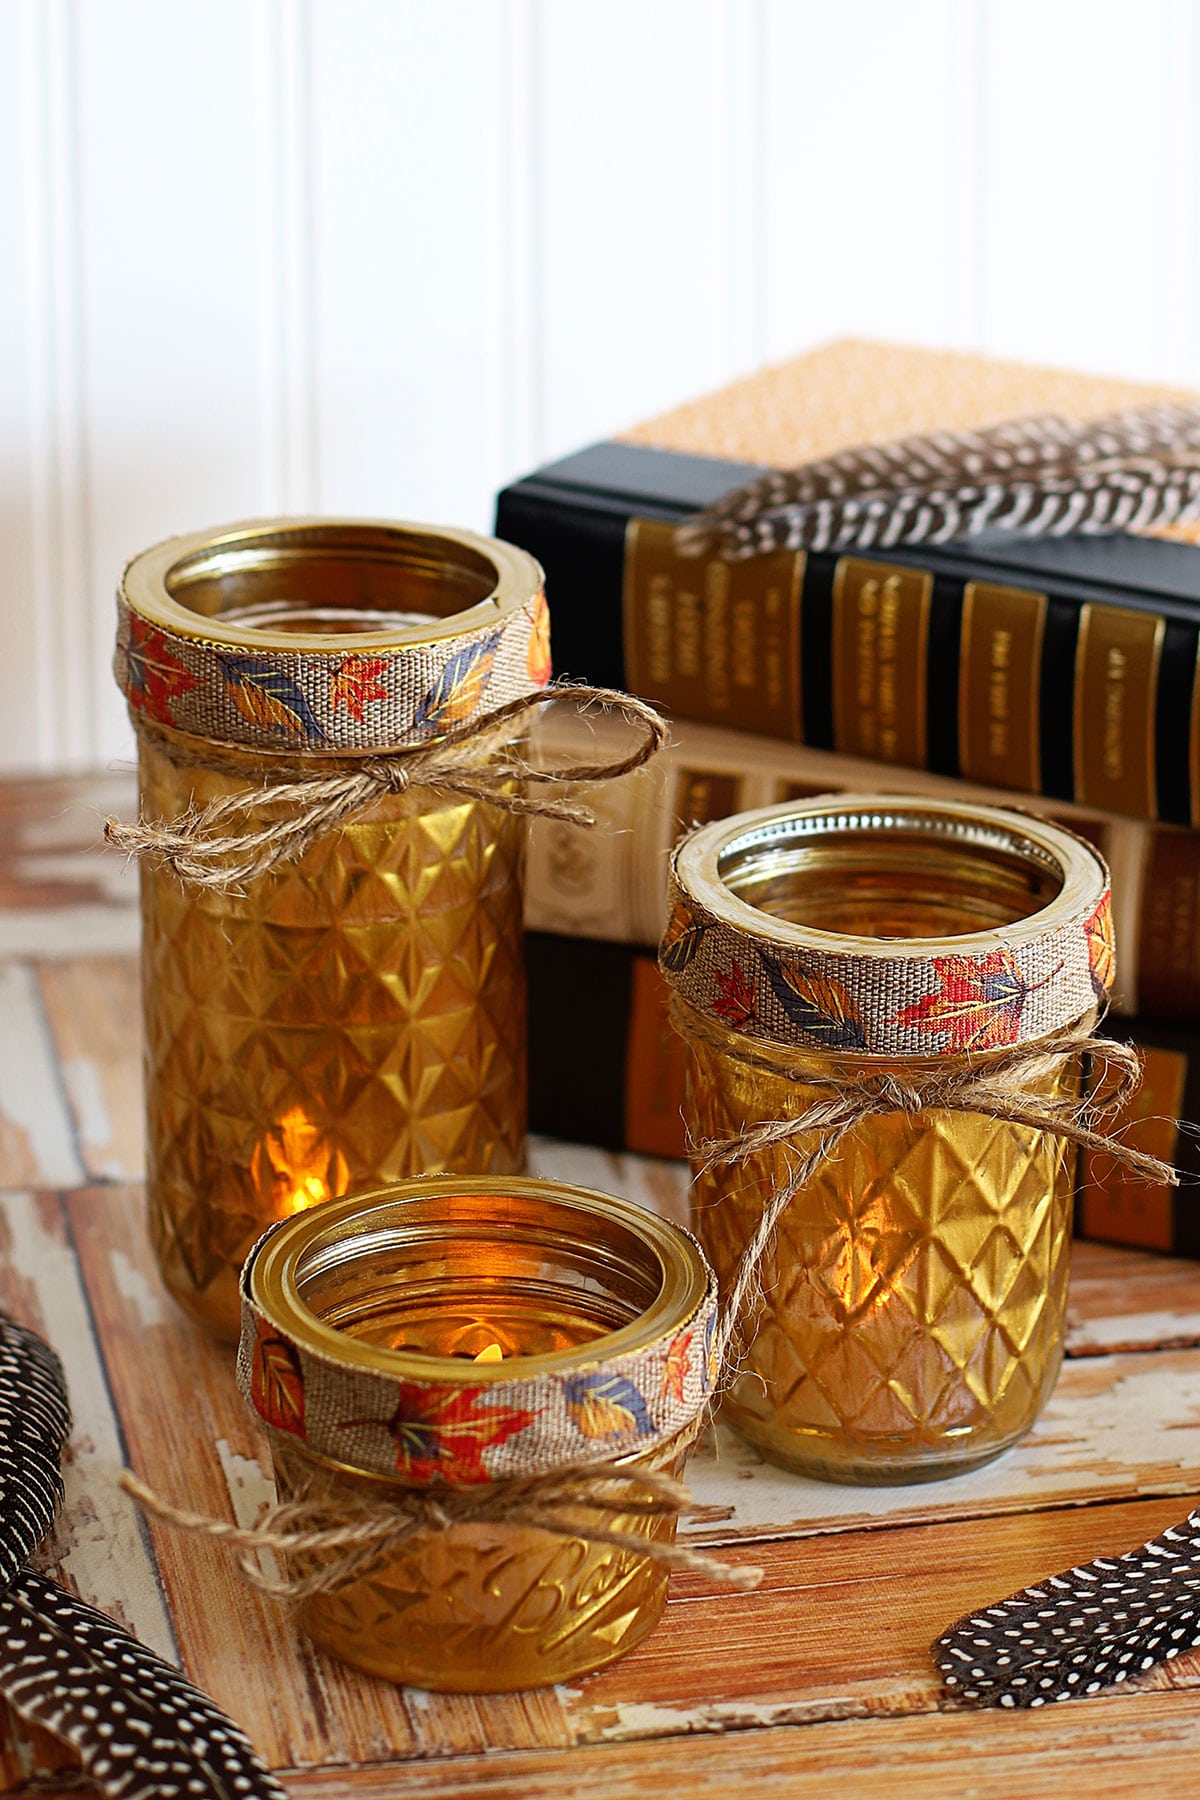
(525, 716), (1165, 1019)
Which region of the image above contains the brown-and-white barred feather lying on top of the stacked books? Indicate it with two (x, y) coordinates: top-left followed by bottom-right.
(678, 405), (1200, 560)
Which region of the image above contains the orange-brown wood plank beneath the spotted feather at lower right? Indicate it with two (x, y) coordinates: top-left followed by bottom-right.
(567, 1499), (1200, 1742)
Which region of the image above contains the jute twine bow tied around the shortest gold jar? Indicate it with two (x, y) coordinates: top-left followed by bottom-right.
(121, 1415), (763, 1600)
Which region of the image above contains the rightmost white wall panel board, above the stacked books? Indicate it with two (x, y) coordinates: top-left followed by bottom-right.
(981, 0), (1196, 378)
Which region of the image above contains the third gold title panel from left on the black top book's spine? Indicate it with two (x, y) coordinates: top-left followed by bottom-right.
(959, 581), (1047, 794)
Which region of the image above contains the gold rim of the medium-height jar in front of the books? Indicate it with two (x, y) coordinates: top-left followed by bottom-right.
(675, 794), (1106, 961)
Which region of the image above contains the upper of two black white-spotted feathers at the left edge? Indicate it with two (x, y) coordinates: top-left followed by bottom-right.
(0, 1314), (70, 1588)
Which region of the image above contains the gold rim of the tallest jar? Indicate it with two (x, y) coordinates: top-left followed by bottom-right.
(121, 515), (543, 655)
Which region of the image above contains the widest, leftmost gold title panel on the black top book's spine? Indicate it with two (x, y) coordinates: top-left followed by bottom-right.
(622, 518), (804, 738)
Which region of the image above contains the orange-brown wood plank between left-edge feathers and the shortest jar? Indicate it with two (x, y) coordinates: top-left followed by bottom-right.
(68, 1188), (569, 1764)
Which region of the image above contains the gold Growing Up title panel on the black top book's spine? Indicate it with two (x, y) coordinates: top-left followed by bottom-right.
(1074, 605), (1166, 819)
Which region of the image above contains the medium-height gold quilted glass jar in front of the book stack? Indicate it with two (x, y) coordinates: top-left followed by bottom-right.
(660, 796), (1112, 1481)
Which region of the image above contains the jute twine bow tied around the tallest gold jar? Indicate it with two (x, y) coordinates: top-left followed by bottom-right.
(104, 684), (667, 893)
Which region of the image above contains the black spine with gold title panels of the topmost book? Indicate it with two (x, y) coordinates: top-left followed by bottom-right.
(497, 477), (1200, 826)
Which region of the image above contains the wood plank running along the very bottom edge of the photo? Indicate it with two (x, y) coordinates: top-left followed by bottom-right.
(271, 1690), (1200, 1800)
